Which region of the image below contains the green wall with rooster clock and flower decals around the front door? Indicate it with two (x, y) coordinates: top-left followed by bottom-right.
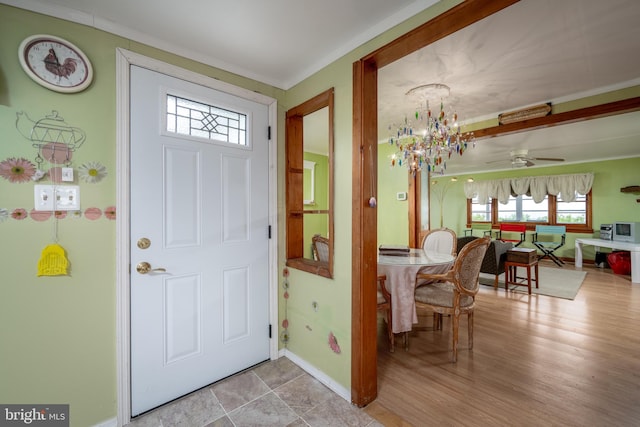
(0, 5), (284, 426)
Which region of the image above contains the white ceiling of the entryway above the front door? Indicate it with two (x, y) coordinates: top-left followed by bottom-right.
(0, 0), (437, 89)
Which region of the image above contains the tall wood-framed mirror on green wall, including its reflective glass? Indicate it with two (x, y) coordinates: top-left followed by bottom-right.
(285, 89), (334, 278)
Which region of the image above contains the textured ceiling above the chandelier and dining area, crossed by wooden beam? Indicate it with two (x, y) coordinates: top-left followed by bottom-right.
(378, 0), (640, 175)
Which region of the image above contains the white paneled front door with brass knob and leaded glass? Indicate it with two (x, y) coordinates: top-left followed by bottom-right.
(130, 66), (270, 416)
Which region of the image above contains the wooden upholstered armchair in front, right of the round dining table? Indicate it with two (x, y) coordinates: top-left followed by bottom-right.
(415, 236), (491, 362)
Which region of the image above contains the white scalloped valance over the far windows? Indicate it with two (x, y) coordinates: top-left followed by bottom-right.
(464, 173), (593, 204)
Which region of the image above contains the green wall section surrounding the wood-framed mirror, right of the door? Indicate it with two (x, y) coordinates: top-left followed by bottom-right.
(280, 0), (459, 392)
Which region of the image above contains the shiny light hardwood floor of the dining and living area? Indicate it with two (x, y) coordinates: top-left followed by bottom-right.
(365, 262), (640, 426)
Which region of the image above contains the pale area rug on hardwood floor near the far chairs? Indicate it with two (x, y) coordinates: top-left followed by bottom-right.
(480, 267), (587, 300)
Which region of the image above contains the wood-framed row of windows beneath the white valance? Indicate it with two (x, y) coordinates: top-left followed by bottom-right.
(467, 192), (593, 233)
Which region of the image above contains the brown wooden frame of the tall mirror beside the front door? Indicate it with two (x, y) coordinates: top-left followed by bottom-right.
(285, 88), (335, 278)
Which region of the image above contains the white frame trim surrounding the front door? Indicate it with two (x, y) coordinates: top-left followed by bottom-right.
(115, 48), (279, 426)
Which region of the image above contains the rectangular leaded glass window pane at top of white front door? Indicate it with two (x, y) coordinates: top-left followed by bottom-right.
(167, 94), (247, 146)
